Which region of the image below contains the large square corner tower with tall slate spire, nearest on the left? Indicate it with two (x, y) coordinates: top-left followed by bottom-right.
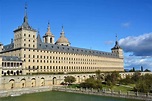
(14, 4), (37, 48)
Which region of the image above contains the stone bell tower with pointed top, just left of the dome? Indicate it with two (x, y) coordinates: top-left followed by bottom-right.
(43, 22), (54, 44)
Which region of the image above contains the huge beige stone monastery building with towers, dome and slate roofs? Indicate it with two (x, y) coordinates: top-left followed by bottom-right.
(0, 5), (124, 76)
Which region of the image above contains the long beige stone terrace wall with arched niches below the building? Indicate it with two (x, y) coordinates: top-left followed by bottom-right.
(0, 74), (95, 90)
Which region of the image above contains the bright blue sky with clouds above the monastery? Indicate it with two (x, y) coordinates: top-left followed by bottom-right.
(0, 0), (152, 70)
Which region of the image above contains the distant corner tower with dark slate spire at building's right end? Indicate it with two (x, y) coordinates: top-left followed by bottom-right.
(111, 35), (123, 59)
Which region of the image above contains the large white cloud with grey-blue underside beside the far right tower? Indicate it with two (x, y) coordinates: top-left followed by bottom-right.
(119, 32), (152, 56)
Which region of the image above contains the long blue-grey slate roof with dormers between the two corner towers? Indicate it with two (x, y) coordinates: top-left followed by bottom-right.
(37, 42), (118, 58)
